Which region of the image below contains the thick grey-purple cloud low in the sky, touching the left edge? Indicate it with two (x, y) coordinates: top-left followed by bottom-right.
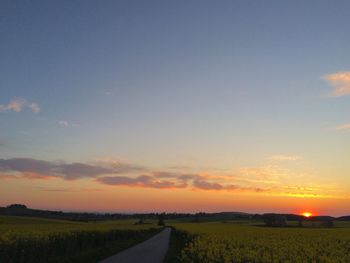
(0, 158), (144, 180)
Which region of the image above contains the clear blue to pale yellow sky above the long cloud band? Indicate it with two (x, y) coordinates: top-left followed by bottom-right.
(0, 1), (350, 214)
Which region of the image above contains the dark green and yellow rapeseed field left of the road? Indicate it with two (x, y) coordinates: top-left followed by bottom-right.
(0, 216), (159, 263)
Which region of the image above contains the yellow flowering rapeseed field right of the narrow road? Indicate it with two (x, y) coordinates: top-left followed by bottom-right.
(172, 221), (350, 263)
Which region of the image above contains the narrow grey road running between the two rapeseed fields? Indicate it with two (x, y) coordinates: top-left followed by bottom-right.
(99, 228), (171, 263)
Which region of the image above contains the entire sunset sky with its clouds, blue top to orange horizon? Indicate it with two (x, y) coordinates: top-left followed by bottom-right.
(0, 0), (350, 215)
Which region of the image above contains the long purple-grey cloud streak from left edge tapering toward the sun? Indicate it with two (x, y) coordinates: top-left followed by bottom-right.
(0, 158), (266, 192)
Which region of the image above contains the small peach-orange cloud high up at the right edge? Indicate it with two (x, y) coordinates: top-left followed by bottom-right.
(323, 71), (350, 97)
